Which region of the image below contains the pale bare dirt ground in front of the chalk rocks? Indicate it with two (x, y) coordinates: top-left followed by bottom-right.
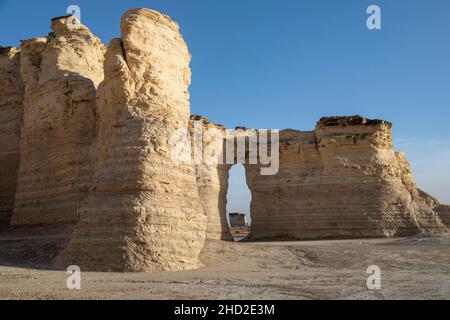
(0, 235), (450, 300)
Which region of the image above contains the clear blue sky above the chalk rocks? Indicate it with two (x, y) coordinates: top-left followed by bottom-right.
(0, 0), (450, 211)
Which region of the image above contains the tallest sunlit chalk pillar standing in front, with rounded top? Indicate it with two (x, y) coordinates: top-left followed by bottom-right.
(55, 9), (206, 271)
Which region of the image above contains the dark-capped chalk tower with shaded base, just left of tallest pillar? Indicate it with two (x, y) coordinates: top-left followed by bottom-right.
(11, 17), (105, 227)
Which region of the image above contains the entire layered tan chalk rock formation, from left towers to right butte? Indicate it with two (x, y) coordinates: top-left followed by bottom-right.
(0, 9), (450, 271)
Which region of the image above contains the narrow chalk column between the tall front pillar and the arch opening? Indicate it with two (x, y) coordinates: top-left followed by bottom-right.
(190, 116), (233, 241)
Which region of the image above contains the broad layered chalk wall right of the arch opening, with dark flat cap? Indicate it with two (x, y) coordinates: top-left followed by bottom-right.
(246, 116), (446, 239)
